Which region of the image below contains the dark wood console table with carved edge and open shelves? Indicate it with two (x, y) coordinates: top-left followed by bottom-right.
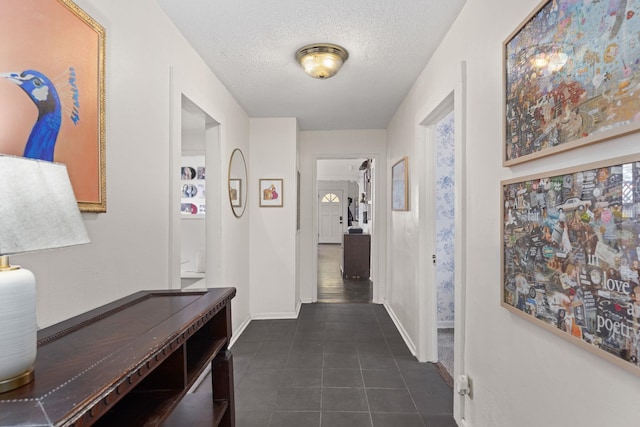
(0, 288), (236, 427)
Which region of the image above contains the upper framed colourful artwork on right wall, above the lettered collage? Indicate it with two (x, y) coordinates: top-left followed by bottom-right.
(503, 0), (640, 166)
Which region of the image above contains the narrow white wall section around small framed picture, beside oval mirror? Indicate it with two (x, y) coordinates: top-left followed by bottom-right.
(250, 118), (299, 319)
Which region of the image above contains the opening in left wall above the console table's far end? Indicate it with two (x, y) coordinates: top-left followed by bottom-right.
(169, 93), (221, 289)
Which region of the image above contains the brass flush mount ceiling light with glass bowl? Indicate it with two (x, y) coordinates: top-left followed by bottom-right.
(296, 43), (349, 79)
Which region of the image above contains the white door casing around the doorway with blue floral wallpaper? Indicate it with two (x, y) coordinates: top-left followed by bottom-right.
(416, 61), (468, 425)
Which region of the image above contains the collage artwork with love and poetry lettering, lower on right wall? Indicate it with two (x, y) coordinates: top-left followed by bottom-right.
(502, 161), (640, 367)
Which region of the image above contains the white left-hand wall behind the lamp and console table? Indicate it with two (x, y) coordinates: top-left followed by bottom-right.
(12, 0), (249, 334)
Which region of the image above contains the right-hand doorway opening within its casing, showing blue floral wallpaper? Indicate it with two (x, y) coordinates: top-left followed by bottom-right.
(419, 93), (460, 370)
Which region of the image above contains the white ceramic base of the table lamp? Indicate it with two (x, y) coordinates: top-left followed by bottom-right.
(0, 268), (38, 393)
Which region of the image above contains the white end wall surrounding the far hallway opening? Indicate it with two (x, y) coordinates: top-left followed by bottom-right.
(299, 130), (387, 302)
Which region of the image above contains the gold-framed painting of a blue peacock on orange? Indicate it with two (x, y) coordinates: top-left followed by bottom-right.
(0, 0), (106, 212)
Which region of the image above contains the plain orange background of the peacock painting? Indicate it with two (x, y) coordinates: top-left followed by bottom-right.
(0, 0), (100, 202)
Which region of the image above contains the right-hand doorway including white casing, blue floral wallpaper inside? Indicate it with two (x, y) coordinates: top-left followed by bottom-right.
(417, 62), (468, 423)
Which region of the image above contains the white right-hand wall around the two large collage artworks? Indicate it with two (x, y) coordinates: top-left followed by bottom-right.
(387, 0), (640, 427)
